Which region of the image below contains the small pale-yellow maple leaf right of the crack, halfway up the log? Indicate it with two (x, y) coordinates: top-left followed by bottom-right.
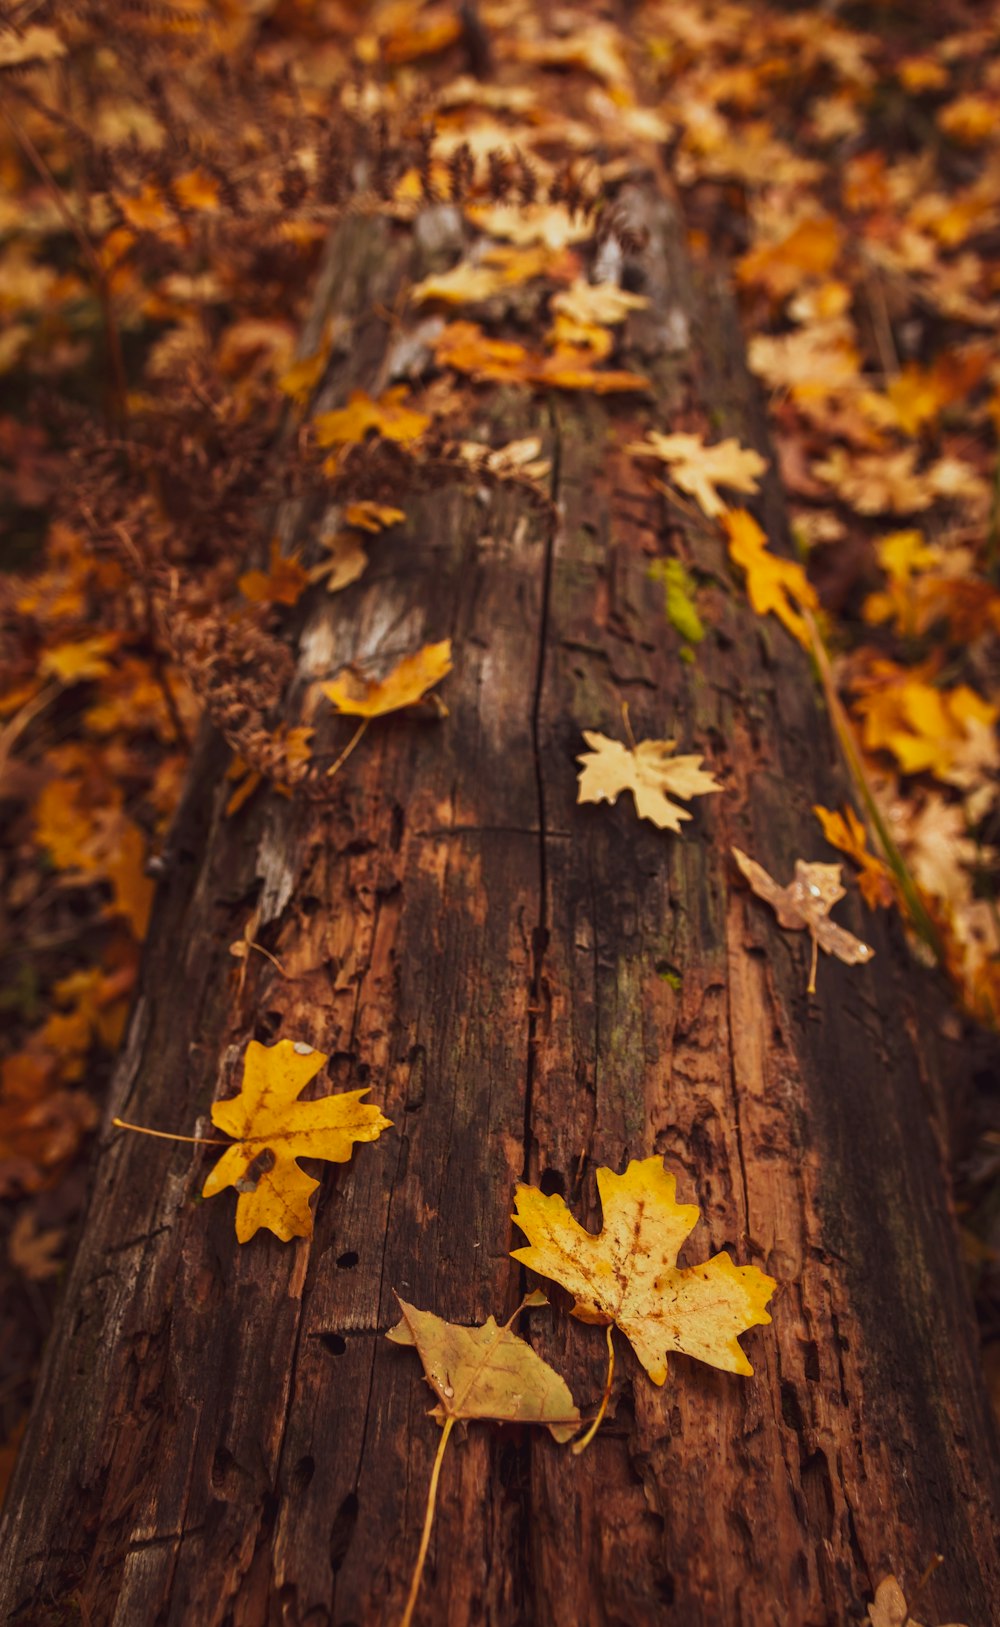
(577, 729), (722, 831)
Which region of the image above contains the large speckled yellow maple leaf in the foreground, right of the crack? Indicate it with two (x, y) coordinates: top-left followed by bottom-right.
(511, 1158), (777, 1385)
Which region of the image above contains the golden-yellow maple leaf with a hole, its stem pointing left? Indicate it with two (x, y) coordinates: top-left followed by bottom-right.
(202, 1040), (392, 1243)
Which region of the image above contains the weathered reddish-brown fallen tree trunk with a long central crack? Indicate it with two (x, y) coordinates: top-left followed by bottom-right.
(0, 193), (1000, 1627)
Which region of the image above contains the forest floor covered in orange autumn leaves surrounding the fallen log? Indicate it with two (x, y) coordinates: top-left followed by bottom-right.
(0, 0), (1000, 1494)
